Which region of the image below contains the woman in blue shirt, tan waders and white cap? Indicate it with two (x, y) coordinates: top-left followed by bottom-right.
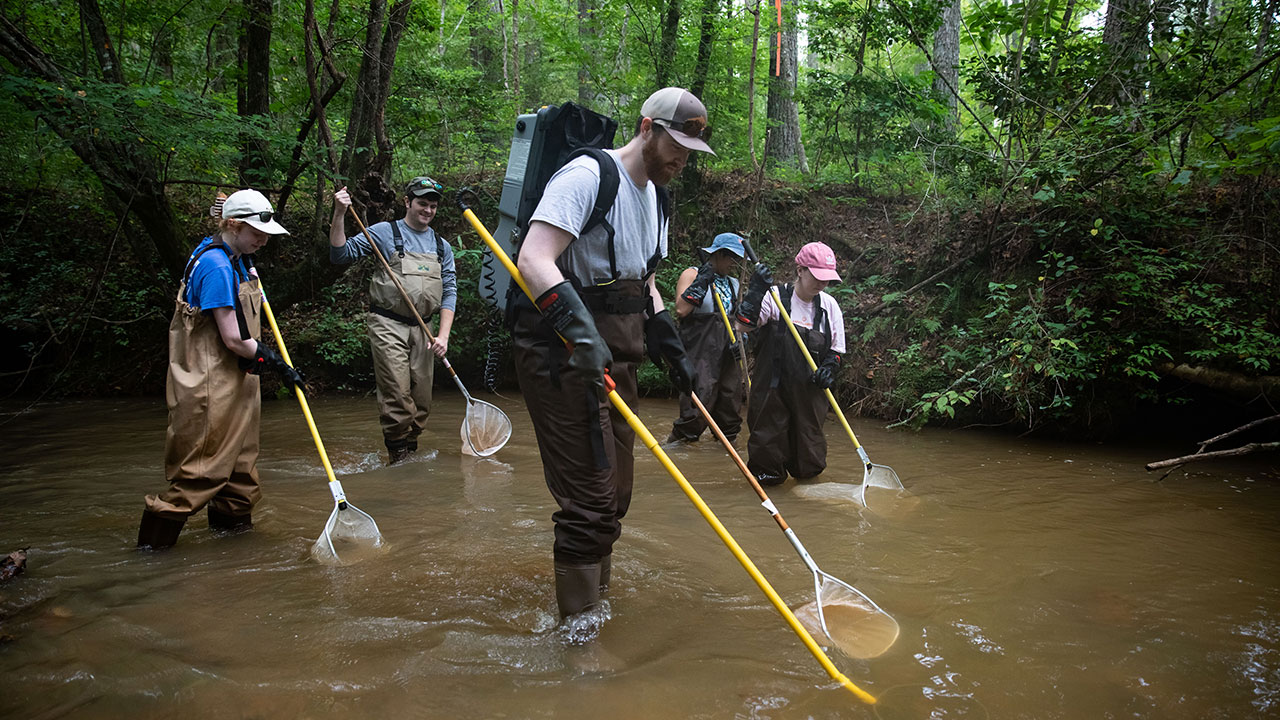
(138, 190), (302, 548)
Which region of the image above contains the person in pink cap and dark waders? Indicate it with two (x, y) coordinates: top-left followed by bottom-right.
(737, 242), (845, 486)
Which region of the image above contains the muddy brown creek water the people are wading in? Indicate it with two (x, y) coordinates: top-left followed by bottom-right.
(0, 395), (1280, 720)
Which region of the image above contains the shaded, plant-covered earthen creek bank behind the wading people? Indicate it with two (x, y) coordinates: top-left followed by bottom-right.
(0, 172), (1280, 438)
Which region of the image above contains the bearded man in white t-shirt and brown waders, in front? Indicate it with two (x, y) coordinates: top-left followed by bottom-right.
(513, 87), (710, 619)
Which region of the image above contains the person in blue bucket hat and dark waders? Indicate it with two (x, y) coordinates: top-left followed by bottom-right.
(667, 232), (746, 442)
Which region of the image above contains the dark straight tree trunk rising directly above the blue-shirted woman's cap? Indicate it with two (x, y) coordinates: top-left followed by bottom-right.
(237, 0), (271, 186)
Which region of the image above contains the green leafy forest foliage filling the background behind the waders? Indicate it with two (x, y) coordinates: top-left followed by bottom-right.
(0, 0), (1280, 443)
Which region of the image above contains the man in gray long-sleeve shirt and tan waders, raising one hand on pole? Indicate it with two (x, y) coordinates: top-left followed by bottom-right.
(329, 177), (458, 465)
